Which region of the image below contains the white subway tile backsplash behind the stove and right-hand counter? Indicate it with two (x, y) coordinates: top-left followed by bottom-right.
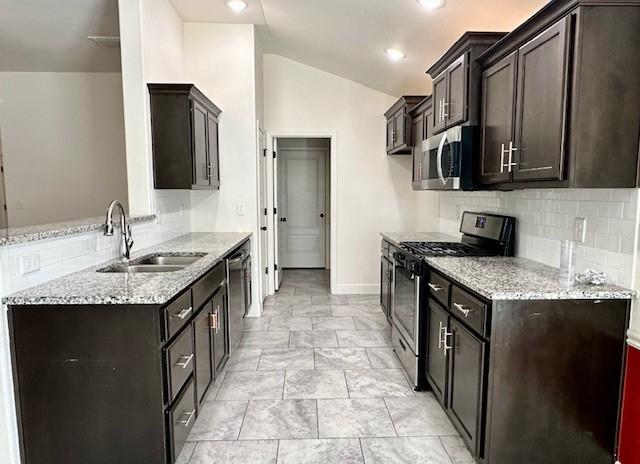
(440, 189), (639, 287)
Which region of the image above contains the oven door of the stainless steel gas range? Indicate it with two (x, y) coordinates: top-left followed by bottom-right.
(392, 261), (420, 355)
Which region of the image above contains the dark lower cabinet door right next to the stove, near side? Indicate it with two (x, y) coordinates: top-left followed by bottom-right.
(427, 300), (449, 405)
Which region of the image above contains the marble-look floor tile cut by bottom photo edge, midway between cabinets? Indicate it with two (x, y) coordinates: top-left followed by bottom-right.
(278, 438), (364, 464)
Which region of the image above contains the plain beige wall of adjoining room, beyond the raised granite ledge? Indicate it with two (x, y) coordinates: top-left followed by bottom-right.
(0, 72), (128, 227)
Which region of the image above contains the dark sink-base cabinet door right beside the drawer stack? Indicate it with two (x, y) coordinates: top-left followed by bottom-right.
(193, 303), (214, 405)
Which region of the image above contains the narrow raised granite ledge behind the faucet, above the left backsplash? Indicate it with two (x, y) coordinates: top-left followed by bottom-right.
(0, 214), (156, 246)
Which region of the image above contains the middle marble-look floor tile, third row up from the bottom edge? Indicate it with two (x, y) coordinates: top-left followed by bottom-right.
(284, 370), (349, 399)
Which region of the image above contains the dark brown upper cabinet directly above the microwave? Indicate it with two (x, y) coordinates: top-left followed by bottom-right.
(427, 32), (506, 134)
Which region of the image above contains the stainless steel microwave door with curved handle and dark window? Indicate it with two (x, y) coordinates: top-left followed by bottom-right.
(420, 126), (462, 190)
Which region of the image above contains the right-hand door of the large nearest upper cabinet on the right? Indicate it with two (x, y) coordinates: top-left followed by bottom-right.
(513, 18), (569, 181)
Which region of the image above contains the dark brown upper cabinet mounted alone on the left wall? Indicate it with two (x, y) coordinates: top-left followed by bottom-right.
(149, 84), (221, 190)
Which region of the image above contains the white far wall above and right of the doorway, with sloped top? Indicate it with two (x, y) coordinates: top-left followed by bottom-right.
(264, 54), (437, 293)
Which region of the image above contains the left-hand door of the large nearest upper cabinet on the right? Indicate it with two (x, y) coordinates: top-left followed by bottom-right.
(480, 53), (517, 184)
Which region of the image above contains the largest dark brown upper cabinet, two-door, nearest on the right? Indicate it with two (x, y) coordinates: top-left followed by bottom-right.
(478, 0), (640, 190)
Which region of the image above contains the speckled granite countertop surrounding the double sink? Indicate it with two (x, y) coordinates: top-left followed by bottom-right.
(7, 232), (251, 305)
